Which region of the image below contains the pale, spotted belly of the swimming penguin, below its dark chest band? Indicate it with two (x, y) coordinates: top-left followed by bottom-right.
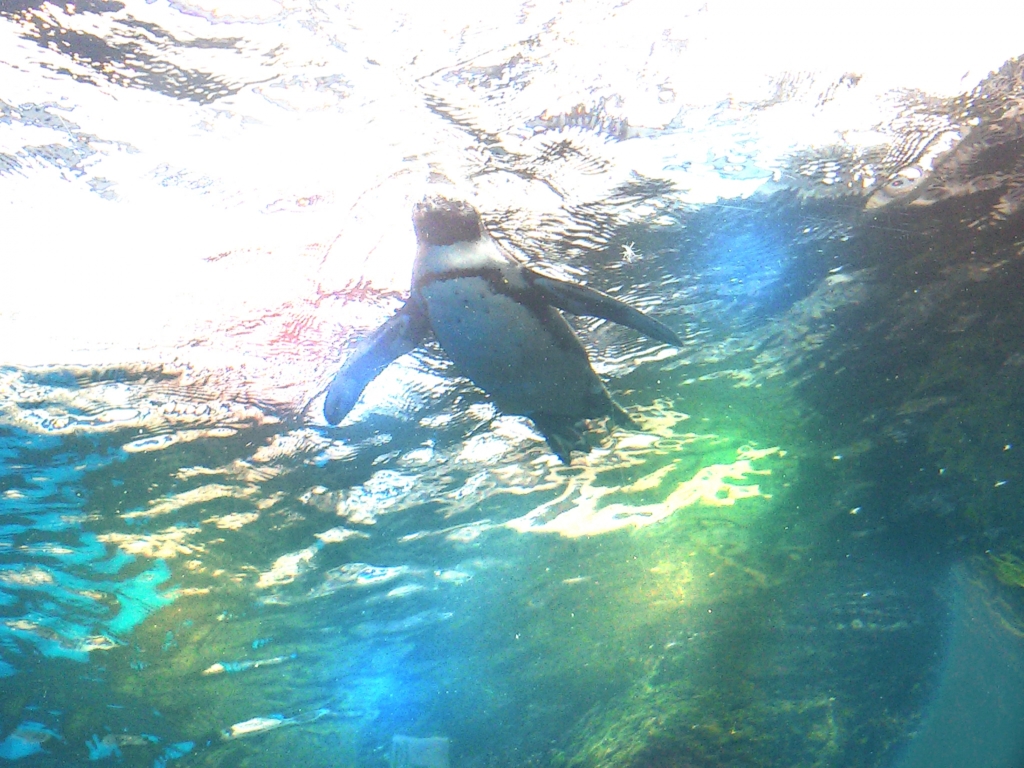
(420, 276), (610, 418)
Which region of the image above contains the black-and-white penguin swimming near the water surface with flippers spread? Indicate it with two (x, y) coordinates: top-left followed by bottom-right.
(324, 197), (682, 464)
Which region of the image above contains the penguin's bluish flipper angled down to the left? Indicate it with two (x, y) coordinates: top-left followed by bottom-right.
(324, 298), (430, 424)
